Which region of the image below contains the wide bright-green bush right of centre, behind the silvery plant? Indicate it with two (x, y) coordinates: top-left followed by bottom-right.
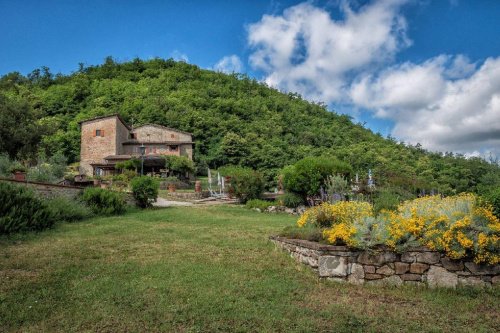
(283, 157), (352, 199)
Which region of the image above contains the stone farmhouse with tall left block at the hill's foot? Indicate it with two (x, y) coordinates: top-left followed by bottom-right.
(80, 114), (193, 176)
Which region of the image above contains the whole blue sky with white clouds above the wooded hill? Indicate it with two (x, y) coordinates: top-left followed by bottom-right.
(0, 0), (500, 155)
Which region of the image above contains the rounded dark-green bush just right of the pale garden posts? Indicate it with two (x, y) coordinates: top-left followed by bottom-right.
(225, 167), (264, 203)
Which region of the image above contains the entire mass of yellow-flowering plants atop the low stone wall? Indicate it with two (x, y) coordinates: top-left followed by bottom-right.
(297, 194), (500, 265)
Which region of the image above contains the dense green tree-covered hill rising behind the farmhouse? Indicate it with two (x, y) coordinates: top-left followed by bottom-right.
(0, 57), (500, 193)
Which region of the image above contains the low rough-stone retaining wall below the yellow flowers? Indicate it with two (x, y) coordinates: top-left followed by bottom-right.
(271, 237), (500, 288)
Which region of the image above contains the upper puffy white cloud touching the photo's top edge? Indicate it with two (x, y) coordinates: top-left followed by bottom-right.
(248, 0), (410, 103)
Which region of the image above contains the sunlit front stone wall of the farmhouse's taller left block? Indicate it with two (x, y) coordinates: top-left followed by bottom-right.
(80, 117), (121, 175)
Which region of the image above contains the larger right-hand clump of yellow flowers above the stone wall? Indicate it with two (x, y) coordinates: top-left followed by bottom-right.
(386, 194), (500, 264)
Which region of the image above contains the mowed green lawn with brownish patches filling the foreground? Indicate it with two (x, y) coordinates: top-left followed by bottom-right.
(0, 206), (500, 332)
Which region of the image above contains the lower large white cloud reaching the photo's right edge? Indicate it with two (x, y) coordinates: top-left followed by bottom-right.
(351, 56), (500, 154)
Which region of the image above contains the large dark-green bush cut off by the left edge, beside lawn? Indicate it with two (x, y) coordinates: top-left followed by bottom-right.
(0, 183), (56, 234)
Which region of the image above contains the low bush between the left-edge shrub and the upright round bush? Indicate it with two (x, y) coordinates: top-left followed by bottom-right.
(82, 187), (127, 215)
